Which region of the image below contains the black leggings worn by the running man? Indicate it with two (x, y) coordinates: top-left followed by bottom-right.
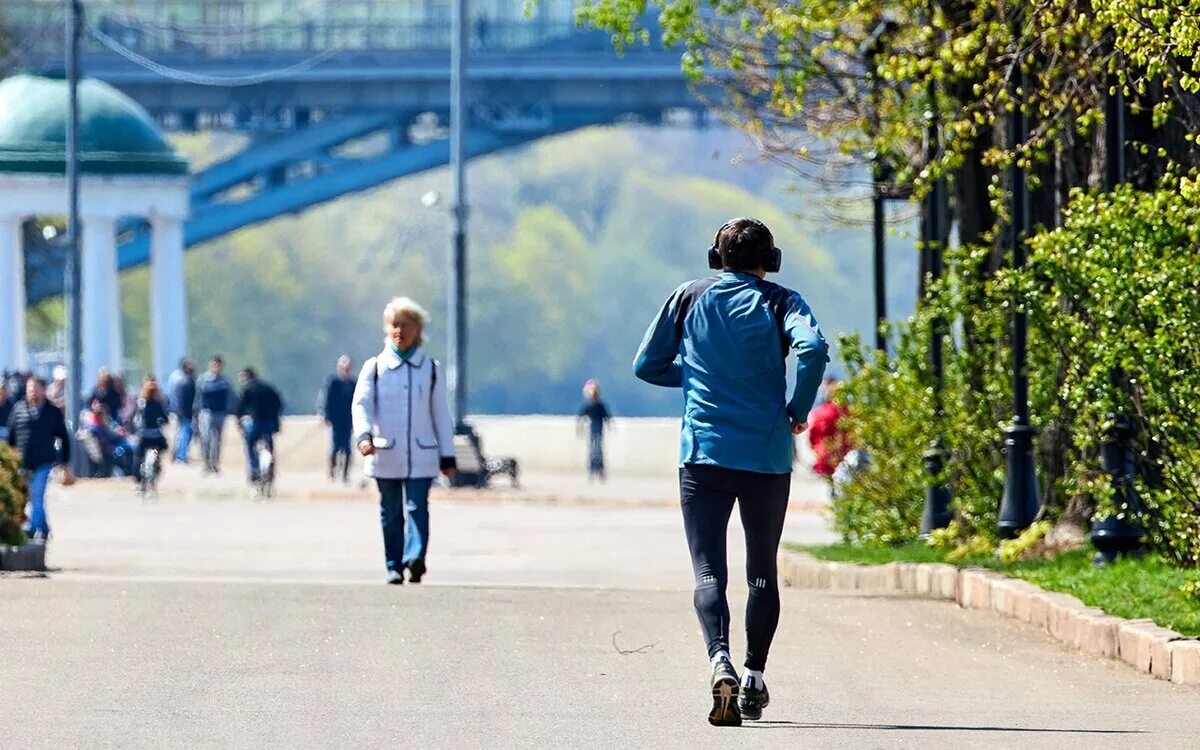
(679, 463), (792, 671)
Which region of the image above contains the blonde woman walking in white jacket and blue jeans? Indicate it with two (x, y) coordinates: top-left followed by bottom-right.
(352, 298), (455, 584)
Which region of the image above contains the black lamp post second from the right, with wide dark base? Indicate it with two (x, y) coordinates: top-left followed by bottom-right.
(998, 38), (1042, 536)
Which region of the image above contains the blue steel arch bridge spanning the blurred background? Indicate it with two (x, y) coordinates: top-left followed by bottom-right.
(2, 0), (707, 301)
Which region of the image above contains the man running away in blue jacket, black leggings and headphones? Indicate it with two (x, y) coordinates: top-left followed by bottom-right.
(634, 218), (829, 726)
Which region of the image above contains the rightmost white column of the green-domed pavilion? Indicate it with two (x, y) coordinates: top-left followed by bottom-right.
(150, 214), (187, 384)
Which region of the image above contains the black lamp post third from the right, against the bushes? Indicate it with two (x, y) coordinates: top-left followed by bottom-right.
(920, 82), (953, 535)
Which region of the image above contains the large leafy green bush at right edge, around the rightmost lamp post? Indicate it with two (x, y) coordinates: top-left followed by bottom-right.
(1027, 187), (1200, 566)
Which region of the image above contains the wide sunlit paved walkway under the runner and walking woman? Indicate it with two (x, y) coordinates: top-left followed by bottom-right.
(0, 477), (1200, 750)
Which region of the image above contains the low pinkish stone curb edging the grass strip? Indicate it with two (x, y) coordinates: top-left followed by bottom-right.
(779, 551), (1200, 685)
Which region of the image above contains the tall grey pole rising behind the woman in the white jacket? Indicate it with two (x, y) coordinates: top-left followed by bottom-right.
(446, 0), (468, 433)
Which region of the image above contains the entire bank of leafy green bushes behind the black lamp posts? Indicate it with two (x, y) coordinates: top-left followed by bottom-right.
(833, 188), (1200, 566)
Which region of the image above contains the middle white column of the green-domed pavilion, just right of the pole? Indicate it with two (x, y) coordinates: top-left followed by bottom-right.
(82, 215), (122, 379)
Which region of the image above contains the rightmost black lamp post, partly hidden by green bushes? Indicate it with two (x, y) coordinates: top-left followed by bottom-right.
(1091, 70), (1146, 565)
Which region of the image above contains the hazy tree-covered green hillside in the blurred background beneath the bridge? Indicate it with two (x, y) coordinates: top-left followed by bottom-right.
(31, 126), (917, 415)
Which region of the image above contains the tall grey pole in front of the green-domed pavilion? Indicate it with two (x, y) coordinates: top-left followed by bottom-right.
(64, 0), (83, 456)
